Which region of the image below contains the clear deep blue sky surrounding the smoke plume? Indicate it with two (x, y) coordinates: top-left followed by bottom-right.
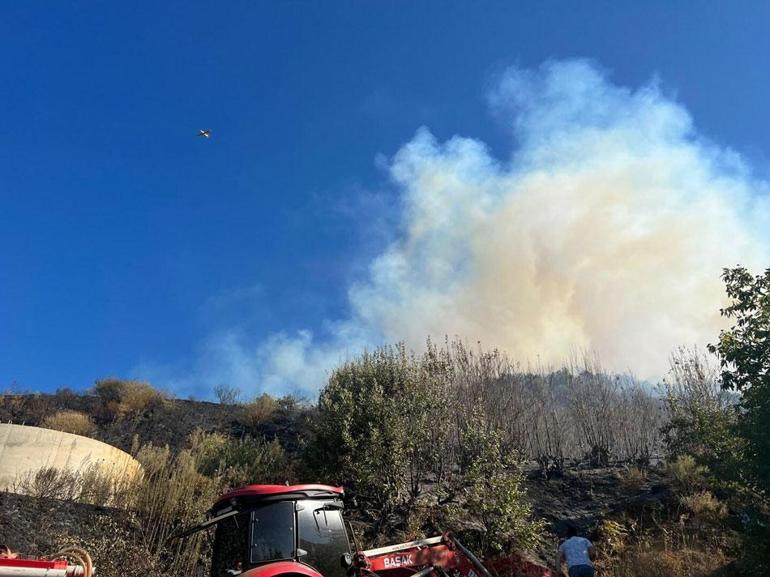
(0, 1), (770, 396)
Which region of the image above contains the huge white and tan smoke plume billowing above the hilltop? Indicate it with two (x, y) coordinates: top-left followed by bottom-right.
(178, 61), (770, 394)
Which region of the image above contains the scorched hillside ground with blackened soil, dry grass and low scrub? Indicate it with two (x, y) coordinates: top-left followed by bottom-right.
(0, 374), (752, 577)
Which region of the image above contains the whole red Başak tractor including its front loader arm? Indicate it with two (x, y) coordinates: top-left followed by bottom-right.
(185, 485), (552, 577)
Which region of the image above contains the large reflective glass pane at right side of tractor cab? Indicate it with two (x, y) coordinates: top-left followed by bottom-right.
(298, 501), (350, 577)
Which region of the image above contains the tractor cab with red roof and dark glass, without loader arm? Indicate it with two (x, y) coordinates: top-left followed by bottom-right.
(206, 485), (350, 577)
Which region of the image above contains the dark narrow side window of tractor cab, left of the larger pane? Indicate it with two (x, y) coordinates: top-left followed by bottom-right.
(249, 501), (294, 564)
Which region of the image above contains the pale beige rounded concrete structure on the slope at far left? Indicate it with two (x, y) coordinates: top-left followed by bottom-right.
(0, 424), (141, 491)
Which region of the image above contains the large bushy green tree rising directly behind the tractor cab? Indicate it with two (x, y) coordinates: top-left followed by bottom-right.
(311, 341), (454, 513)
